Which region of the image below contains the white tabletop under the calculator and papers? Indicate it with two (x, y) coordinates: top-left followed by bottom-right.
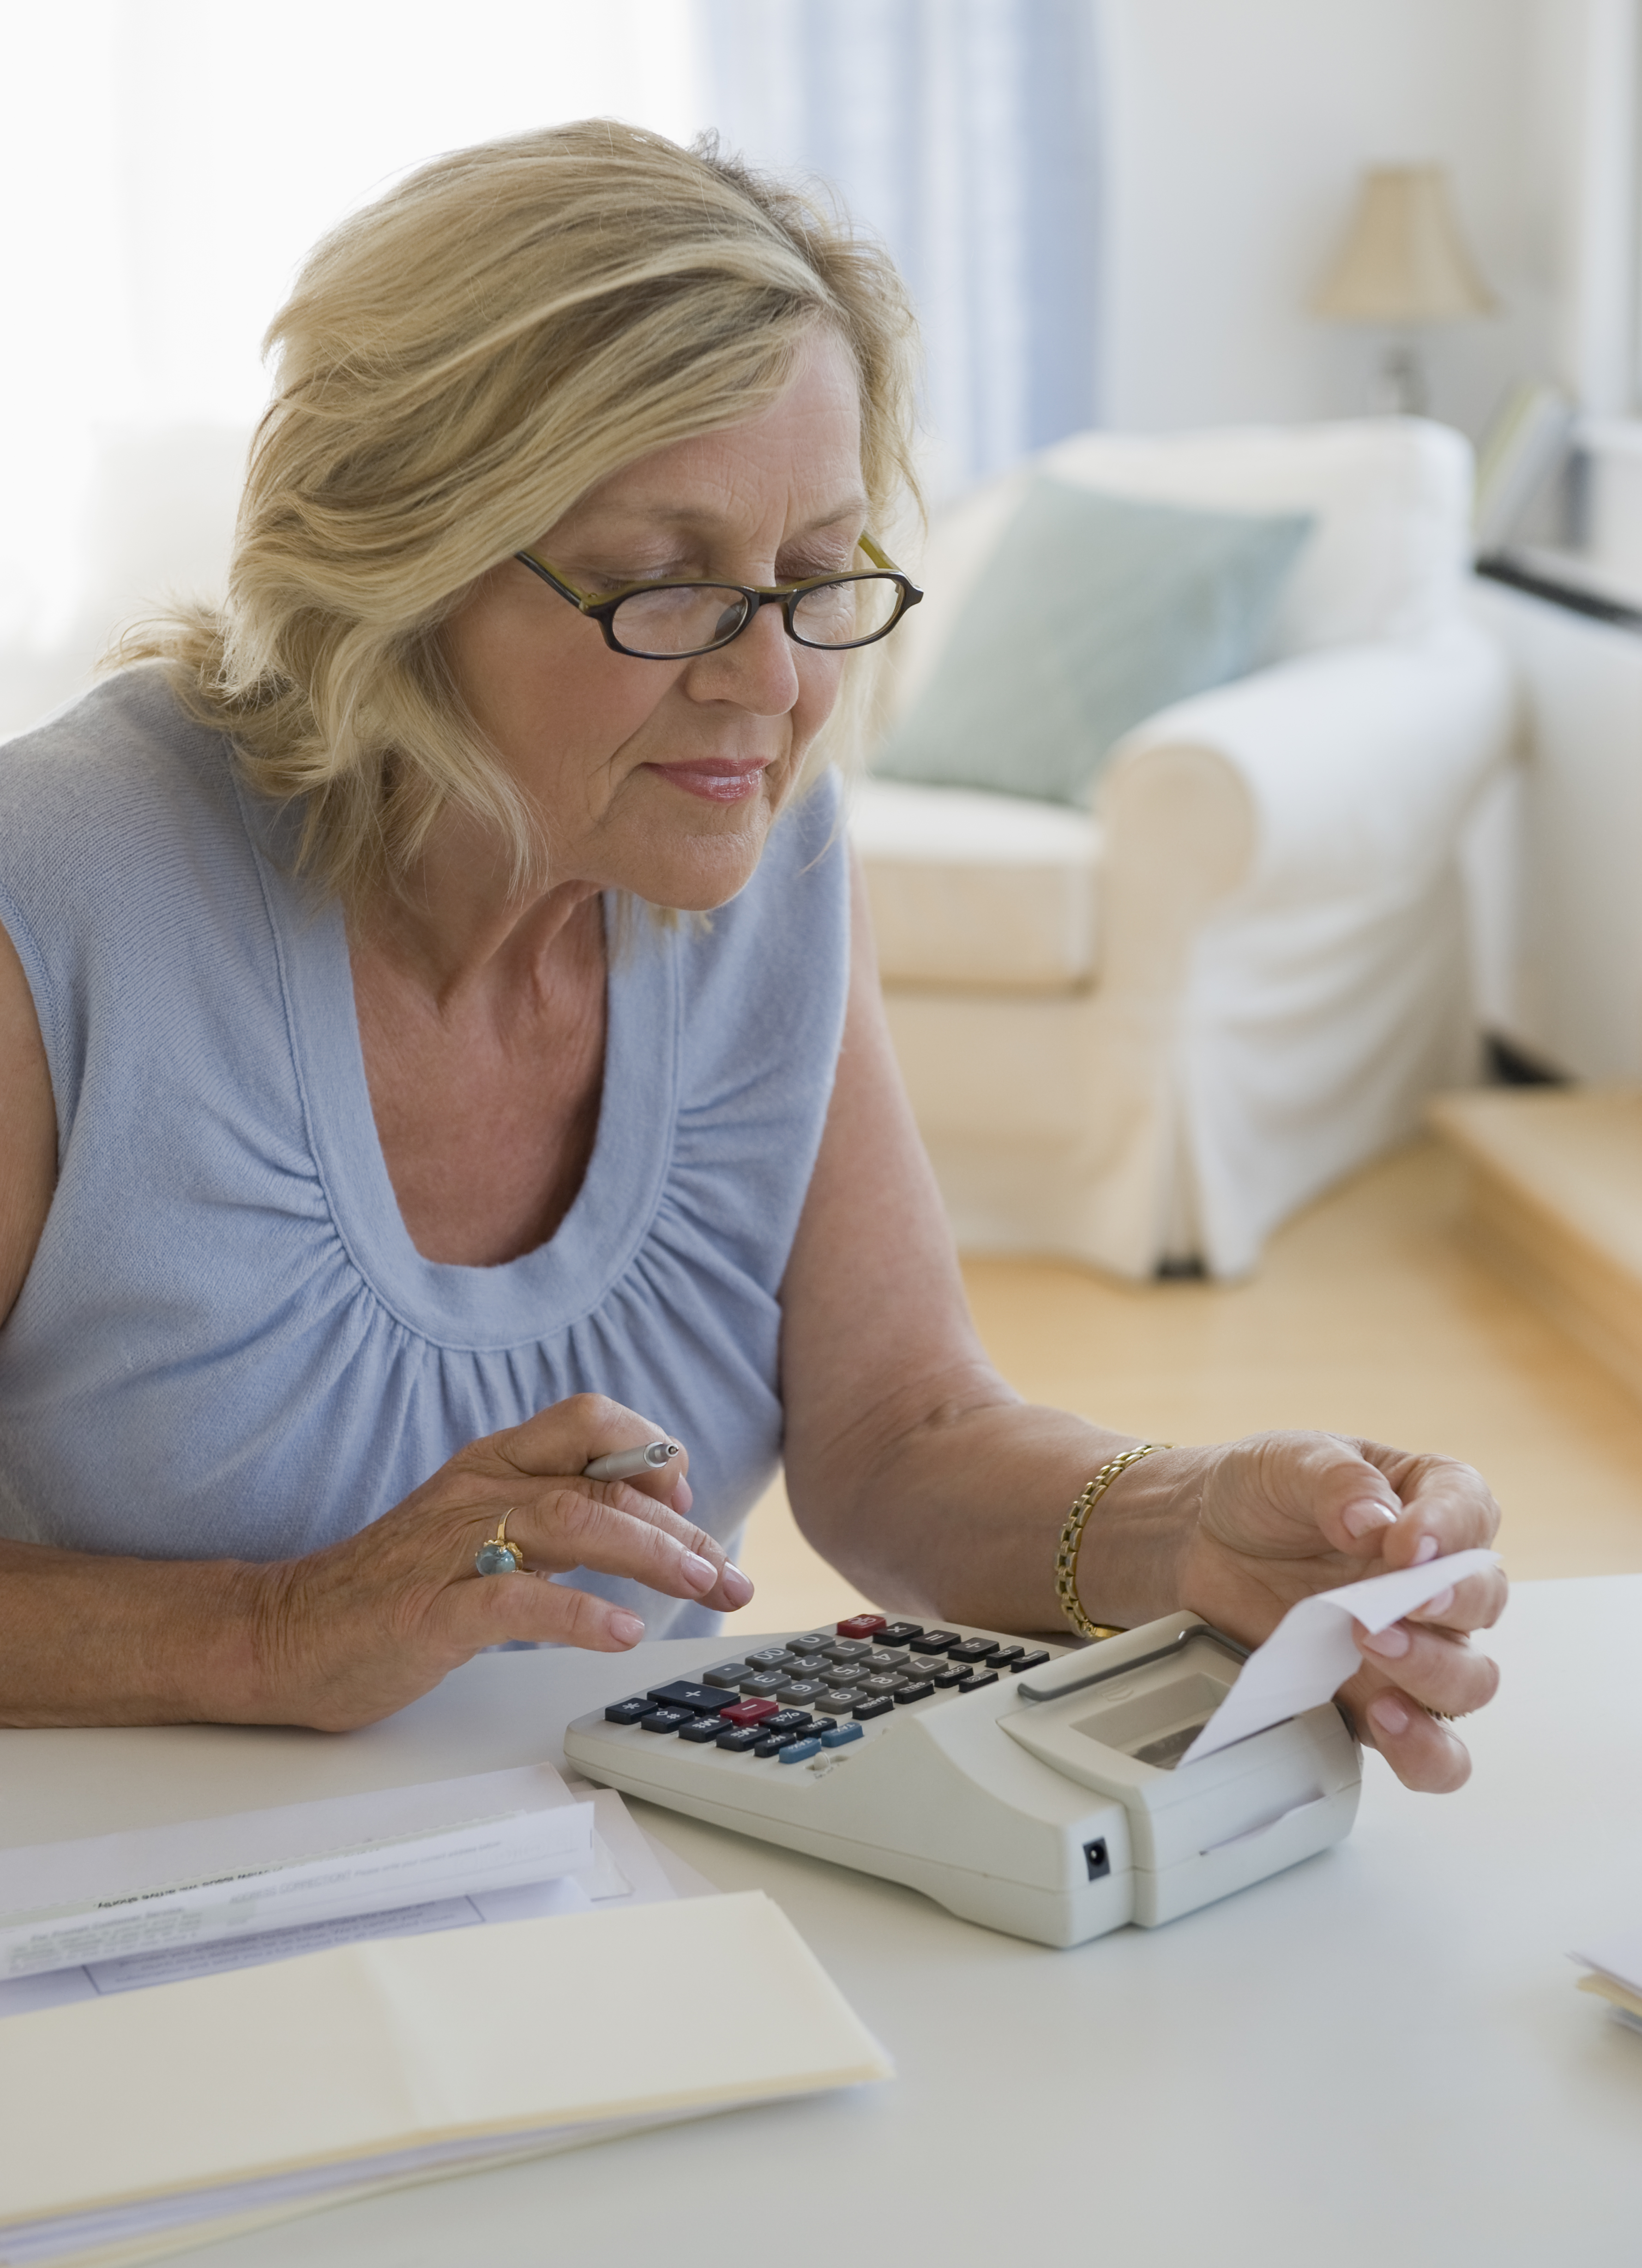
(0, 1576), (1642, 2268)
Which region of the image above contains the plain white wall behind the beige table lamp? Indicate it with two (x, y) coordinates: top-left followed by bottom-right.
(1102, 0), (1585, 433)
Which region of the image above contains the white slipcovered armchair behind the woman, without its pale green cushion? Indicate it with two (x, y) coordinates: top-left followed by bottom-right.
(850, 420), (1513, 1277)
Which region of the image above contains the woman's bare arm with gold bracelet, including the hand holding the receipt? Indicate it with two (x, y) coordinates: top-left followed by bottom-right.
(782, 852), (1504, 1787)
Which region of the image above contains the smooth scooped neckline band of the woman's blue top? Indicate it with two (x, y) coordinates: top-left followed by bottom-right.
(234, 780), (678, 1354)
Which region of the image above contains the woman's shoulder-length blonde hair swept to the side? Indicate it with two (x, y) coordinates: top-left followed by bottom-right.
(125, 120), (916, 903)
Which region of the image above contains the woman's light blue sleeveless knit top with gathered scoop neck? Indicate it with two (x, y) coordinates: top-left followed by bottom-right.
(0, 669), (848, 1638)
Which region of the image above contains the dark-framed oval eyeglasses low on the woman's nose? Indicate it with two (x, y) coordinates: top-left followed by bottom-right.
(515, 535), (923, 662)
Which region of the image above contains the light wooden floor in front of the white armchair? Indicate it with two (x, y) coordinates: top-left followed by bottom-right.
(735, 1143), (1642, 1631)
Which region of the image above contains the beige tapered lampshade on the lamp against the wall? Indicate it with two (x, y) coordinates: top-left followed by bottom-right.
(1311, 166), (1497, 324)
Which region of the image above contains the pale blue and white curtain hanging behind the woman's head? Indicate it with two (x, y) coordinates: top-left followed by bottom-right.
(701, 0), (1100, 494)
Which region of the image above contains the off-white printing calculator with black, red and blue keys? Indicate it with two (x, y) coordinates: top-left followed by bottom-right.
(565, 1610), (1361, 1946)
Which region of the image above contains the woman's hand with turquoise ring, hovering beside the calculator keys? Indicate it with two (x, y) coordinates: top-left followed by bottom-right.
(245, 1395), (753, 1733)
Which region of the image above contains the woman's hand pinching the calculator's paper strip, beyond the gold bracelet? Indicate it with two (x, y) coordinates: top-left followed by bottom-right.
(1179, 1434), (1506, 1794)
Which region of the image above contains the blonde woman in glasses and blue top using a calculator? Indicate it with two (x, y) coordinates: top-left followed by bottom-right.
(0, 125), (1504, 1787)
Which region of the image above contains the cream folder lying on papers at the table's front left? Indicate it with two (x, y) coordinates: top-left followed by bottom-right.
(0, 1891), (891, 2268)
